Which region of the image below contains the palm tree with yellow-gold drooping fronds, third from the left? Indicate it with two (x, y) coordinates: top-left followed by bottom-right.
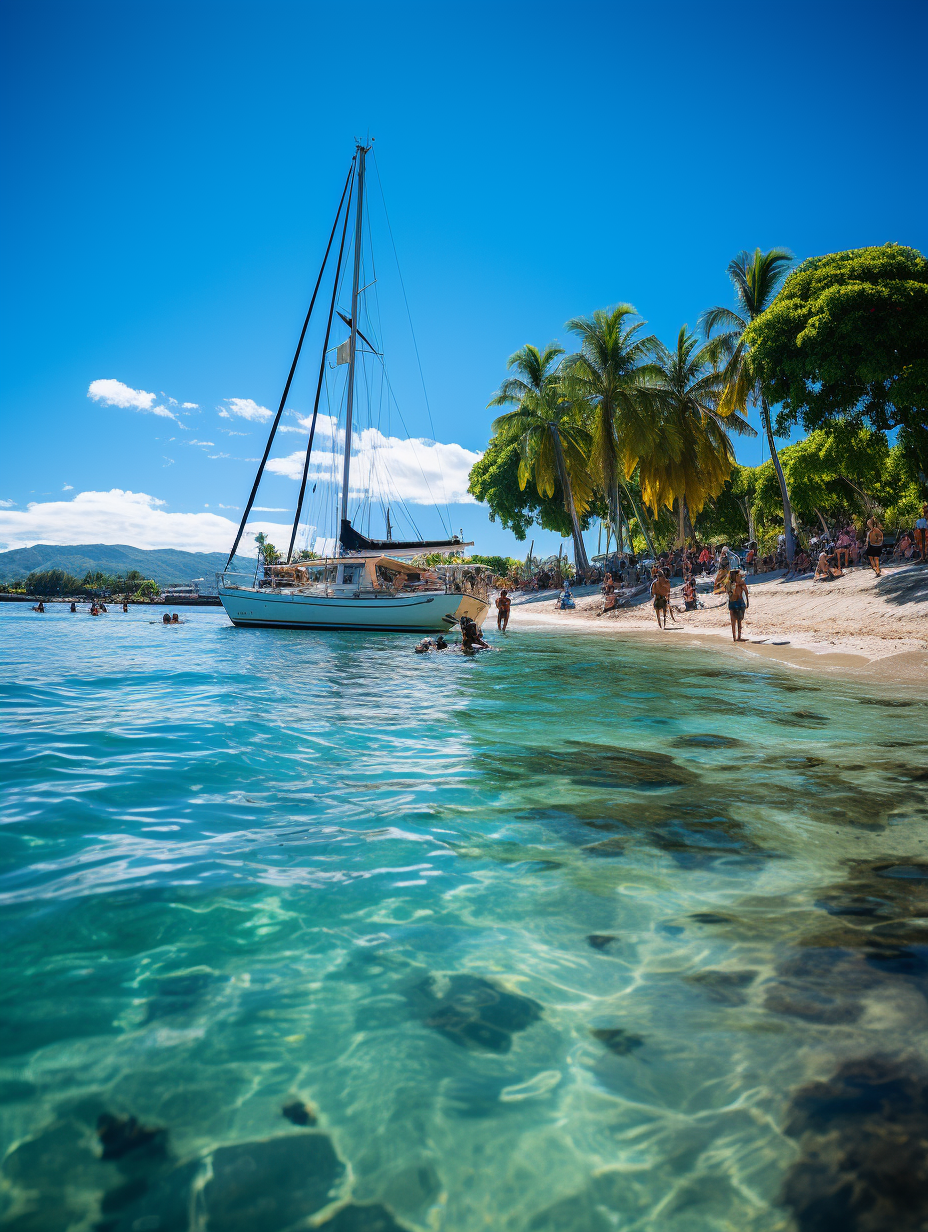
(638, 325), (757, 543)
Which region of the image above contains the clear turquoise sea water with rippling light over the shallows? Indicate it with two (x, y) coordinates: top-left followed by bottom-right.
(0, 605), (928, 1232)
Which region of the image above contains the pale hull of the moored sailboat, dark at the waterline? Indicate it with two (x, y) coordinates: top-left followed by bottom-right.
(219, 586), (489, 633)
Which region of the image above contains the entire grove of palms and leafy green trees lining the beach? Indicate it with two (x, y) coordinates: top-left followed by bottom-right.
(470, 244), (928, 570)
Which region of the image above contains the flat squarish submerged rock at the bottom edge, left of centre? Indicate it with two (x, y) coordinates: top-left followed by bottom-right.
(203, 1133), (345, 1232)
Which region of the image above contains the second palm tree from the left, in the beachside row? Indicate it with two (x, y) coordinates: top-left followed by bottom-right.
(566, 304), (657, 552)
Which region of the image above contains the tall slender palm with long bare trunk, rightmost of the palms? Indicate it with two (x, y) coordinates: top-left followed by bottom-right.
(700, 248), (796, 561)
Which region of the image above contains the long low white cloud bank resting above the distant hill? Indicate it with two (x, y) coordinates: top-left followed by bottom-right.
(0, 488), (290, 553)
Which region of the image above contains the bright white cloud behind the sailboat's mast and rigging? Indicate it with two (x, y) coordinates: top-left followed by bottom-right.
(267, 415), (481, 505)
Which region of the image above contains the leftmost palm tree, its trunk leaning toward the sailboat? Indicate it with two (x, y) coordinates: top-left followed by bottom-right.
(488, 342), (592, 573)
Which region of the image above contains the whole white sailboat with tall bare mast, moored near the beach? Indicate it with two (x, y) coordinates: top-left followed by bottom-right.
(216, 142), (489, 633)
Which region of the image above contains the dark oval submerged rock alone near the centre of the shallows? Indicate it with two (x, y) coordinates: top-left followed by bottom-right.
(407, 976), (542, 1052)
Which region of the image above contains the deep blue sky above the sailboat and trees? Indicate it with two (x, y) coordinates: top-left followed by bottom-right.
(0, 0), (928, 554)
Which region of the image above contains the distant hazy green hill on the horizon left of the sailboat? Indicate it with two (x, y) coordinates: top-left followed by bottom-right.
(0, 543), (255, 586)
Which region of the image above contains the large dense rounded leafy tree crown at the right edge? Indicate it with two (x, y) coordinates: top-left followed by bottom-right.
(746, 244), (928, 485)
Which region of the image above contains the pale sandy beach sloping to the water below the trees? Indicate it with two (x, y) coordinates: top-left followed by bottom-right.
(507, 564), (928, 687)
